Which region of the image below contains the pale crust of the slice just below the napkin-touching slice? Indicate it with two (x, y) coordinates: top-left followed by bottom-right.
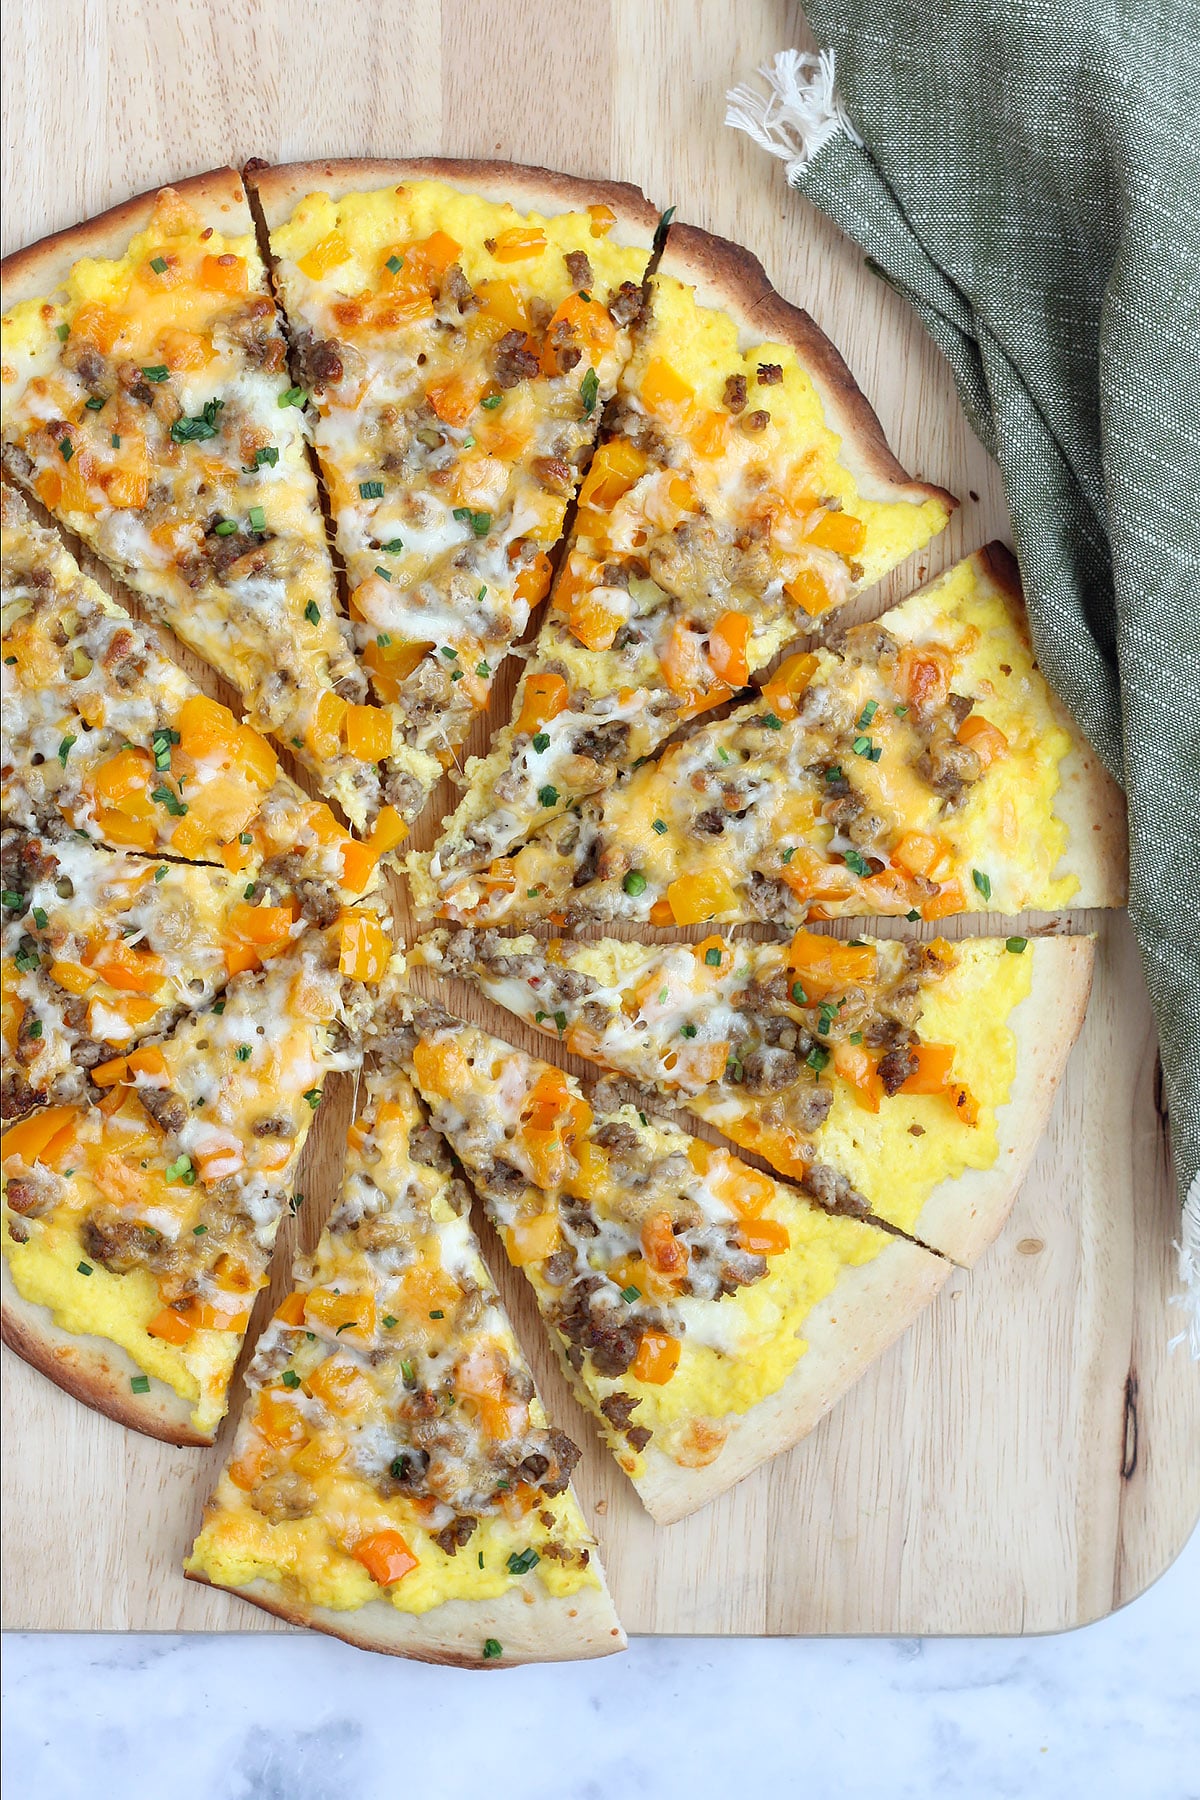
(912, 938), (1096, 1269)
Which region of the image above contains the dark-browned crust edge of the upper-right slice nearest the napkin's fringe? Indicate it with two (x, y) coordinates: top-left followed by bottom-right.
(655, 225), (959, 511)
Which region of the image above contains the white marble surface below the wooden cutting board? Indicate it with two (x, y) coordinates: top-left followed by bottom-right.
(4, 1532), (1200, 1800)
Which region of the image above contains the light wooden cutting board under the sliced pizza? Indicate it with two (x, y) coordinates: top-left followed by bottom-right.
(4, 0), (1200, 1633)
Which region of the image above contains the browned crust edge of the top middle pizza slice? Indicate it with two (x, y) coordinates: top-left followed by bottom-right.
(246, 157), (658, 247)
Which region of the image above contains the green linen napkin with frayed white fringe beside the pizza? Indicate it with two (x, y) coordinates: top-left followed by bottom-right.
(727, 0), (1200, 1355)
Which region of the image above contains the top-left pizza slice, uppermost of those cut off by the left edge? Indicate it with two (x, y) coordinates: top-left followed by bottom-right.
(0, 169), (401, 826)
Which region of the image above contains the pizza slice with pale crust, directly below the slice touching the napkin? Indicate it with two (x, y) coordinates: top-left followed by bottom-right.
(414, 931), (1092, 1264)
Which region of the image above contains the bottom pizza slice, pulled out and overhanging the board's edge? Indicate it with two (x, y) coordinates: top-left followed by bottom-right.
(185, 1057), (624, 1667)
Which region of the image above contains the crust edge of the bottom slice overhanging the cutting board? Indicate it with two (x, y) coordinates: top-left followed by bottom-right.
(185, 1570), (626, 1669)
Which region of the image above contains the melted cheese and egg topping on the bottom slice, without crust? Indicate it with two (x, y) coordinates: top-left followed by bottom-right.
(187, 1071), (599, 1613)
